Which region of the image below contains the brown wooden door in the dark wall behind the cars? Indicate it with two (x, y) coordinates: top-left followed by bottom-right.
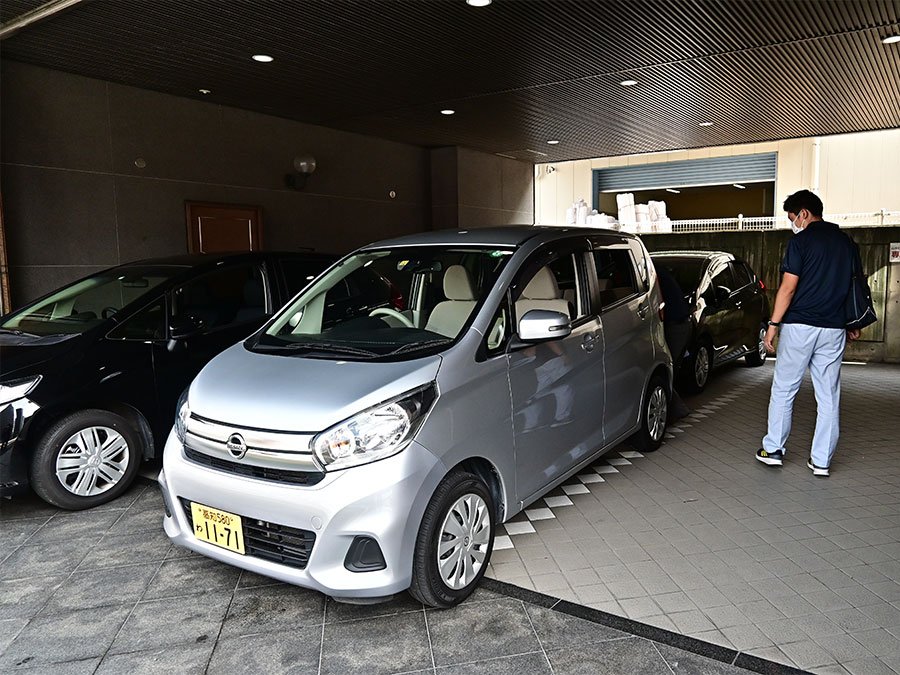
(185, 202), (262, 253)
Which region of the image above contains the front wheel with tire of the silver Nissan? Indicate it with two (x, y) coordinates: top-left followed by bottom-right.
(409, 470), (496, 608)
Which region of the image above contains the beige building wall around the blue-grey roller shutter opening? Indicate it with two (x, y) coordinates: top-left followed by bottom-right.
(535, 129), (900, 225)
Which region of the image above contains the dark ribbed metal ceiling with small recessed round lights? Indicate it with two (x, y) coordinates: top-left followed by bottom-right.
(0, 0), (900, 162)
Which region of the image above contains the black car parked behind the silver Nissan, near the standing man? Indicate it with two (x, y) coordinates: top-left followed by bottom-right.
(650, 251), (769, 393)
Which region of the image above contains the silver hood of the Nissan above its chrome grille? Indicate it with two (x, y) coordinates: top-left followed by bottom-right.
(189, 344), (441, 433)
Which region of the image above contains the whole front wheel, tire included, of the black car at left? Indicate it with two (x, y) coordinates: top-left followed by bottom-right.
(30, 410), (144, 511)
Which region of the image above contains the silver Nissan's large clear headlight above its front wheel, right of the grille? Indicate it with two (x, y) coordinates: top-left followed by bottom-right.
(310, 382), (437, 471)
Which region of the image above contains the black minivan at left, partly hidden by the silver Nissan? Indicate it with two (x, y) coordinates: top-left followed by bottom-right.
(0, 252), (335, 509)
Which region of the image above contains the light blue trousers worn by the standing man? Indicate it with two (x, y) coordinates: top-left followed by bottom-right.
(763, 323), (847, 467)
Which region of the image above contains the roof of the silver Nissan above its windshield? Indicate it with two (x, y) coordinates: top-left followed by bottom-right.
(363, 225), (635, 249)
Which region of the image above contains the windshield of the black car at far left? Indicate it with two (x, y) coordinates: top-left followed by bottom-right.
(0, 266), (181, 335)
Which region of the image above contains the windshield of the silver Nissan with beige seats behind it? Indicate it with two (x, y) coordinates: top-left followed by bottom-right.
(253, 246), (514, 360)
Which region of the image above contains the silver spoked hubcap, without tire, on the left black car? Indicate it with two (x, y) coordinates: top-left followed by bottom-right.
(56, 427), (131, 497)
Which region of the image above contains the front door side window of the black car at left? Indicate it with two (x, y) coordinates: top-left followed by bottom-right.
(172, 265), (266, 330)
